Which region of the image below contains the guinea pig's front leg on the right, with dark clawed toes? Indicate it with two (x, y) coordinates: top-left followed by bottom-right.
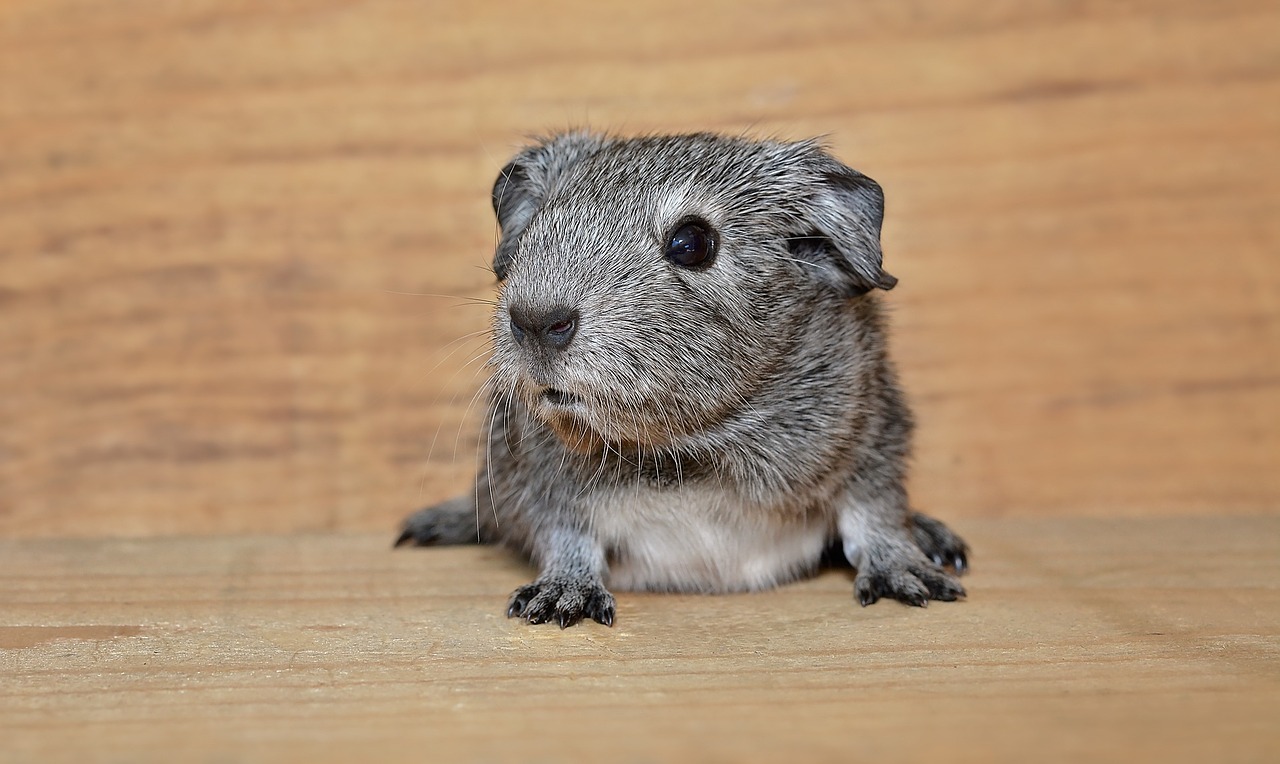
(836, 490), (965, 608)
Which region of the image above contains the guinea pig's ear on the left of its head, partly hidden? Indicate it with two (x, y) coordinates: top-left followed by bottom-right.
(493, 131), (605, 282)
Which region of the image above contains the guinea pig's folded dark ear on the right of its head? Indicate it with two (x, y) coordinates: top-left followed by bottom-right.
(791, 157), (897, 296)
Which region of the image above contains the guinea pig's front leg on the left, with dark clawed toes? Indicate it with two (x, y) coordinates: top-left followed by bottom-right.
(507, 527), (614, 628)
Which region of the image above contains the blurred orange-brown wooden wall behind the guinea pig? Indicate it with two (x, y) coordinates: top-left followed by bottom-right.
(0, 0), (1280, 536)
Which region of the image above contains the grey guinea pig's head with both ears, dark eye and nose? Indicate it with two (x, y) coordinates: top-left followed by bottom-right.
(492, 133), (895, 450)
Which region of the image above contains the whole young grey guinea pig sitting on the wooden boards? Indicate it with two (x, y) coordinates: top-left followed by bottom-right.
(397, 132), (968, 627)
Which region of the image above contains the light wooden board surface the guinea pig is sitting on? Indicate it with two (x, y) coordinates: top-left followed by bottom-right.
(0, 517), (1280, 763)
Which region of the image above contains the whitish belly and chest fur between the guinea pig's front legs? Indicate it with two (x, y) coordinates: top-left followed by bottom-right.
(591, 488), (829, 593)
